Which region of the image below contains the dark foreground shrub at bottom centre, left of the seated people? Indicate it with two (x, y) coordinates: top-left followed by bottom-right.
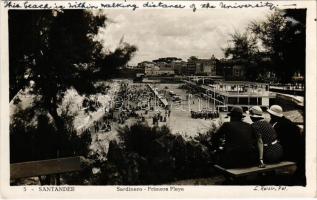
(93, 123), (213, 185)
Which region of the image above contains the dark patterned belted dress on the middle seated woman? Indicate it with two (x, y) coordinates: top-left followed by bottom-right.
(251, 120), (283, 163)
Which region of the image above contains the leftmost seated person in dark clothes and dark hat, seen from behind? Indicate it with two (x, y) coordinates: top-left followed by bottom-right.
(212, 106), (258, 168)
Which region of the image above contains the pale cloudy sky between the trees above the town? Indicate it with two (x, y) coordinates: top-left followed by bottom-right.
(98, 9), (270, 65)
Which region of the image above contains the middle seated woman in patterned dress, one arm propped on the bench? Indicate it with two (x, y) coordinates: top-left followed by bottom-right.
(249, 106), (283, 167)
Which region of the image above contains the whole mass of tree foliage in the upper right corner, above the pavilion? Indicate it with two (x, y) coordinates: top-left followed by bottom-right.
(224, 9), (306, 82)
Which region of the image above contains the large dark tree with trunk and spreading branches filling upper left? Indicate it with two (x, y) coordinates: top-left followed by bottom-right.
(9, 10), (136, 162)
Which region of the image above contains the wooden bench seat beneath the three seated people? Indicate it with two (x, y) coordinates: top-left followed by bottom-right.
(214, 161), (296, 182)
